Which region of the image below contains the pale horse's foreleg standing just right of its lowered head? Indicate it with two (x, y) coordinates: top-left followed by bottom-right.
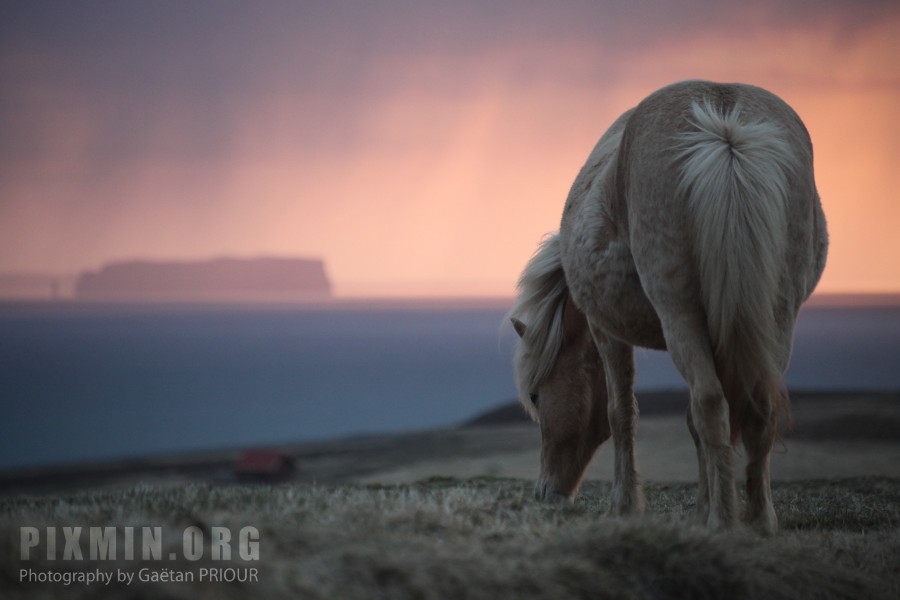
(595, 334), (646, 515)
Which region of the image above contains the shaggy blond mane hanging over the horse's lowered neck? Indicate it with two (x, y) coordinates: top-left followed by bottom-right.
(507, 234), (569, 416)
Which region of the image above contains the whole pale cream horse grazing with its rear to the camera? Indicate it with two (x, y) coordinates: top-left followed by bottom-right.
(508, 81), (828, 534)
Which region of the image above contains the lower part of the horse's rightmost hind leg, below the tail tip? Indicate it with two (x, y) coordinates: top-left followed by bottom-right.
(741, 385), (786, 535)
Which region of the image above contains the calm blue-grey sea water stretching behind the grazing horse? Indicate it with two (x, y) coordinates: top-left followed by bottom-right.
(0, 303), (900, 469)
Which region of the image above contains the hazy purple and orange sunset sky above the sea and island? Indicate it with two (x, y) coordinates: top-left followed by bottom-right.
(0, 0), (900, 296)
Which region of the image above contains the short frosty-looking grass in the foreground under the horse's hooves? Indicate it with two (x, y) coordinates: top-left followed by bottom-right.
(0, 478), (900, 599)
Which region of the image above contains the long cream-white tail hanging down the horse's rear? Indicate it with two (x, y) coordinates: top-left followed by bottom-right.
(680, 102), (796, 441)
